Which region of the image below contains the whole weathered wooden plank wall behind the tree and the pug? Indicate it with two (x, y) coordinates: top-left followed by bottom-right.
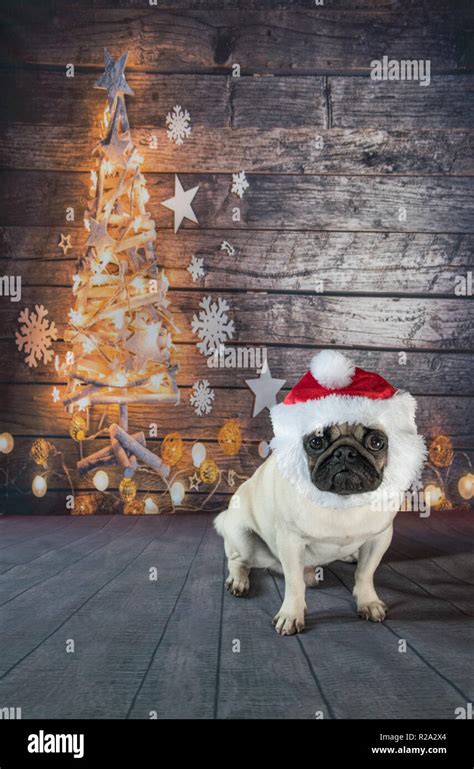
(0, 0), (474, 513)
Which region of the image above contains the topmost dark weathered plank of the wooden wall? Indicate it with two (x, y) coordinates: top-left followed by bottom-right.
(3, 3), (470, 73)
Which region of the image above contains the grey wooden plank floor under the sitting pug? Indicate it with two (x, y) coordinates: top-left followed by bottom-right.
(0, 511), (474, 719)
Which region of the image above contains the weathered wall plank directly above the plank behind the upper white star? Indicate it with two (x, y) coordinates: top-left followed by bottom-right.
(0, 121), (474, 176)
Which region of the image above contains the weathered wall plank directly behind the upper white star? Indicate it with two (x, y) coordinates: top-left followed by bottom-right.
(0, 171), (474, 232)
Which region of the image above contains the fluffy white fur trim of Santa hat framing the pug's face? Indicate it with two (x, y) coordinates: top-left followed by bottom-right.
(270, 390), (426, 509)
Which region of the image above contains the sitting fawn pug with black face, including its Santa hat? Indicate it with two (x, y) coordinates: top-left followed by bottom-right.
(215, 350), (426, 636)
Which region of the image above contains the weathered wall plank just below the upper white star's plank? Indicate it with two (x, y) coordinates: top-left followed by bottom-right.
(0, 227), (474, 296)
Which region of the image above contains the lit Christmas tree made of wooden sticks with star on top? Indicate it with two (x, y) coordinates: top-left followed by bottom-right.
(64, 50), (179, 478)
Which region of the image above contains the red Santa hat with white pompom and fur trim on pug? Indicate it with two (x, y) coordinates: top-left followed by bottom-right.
(270, 350), (426, 508)
